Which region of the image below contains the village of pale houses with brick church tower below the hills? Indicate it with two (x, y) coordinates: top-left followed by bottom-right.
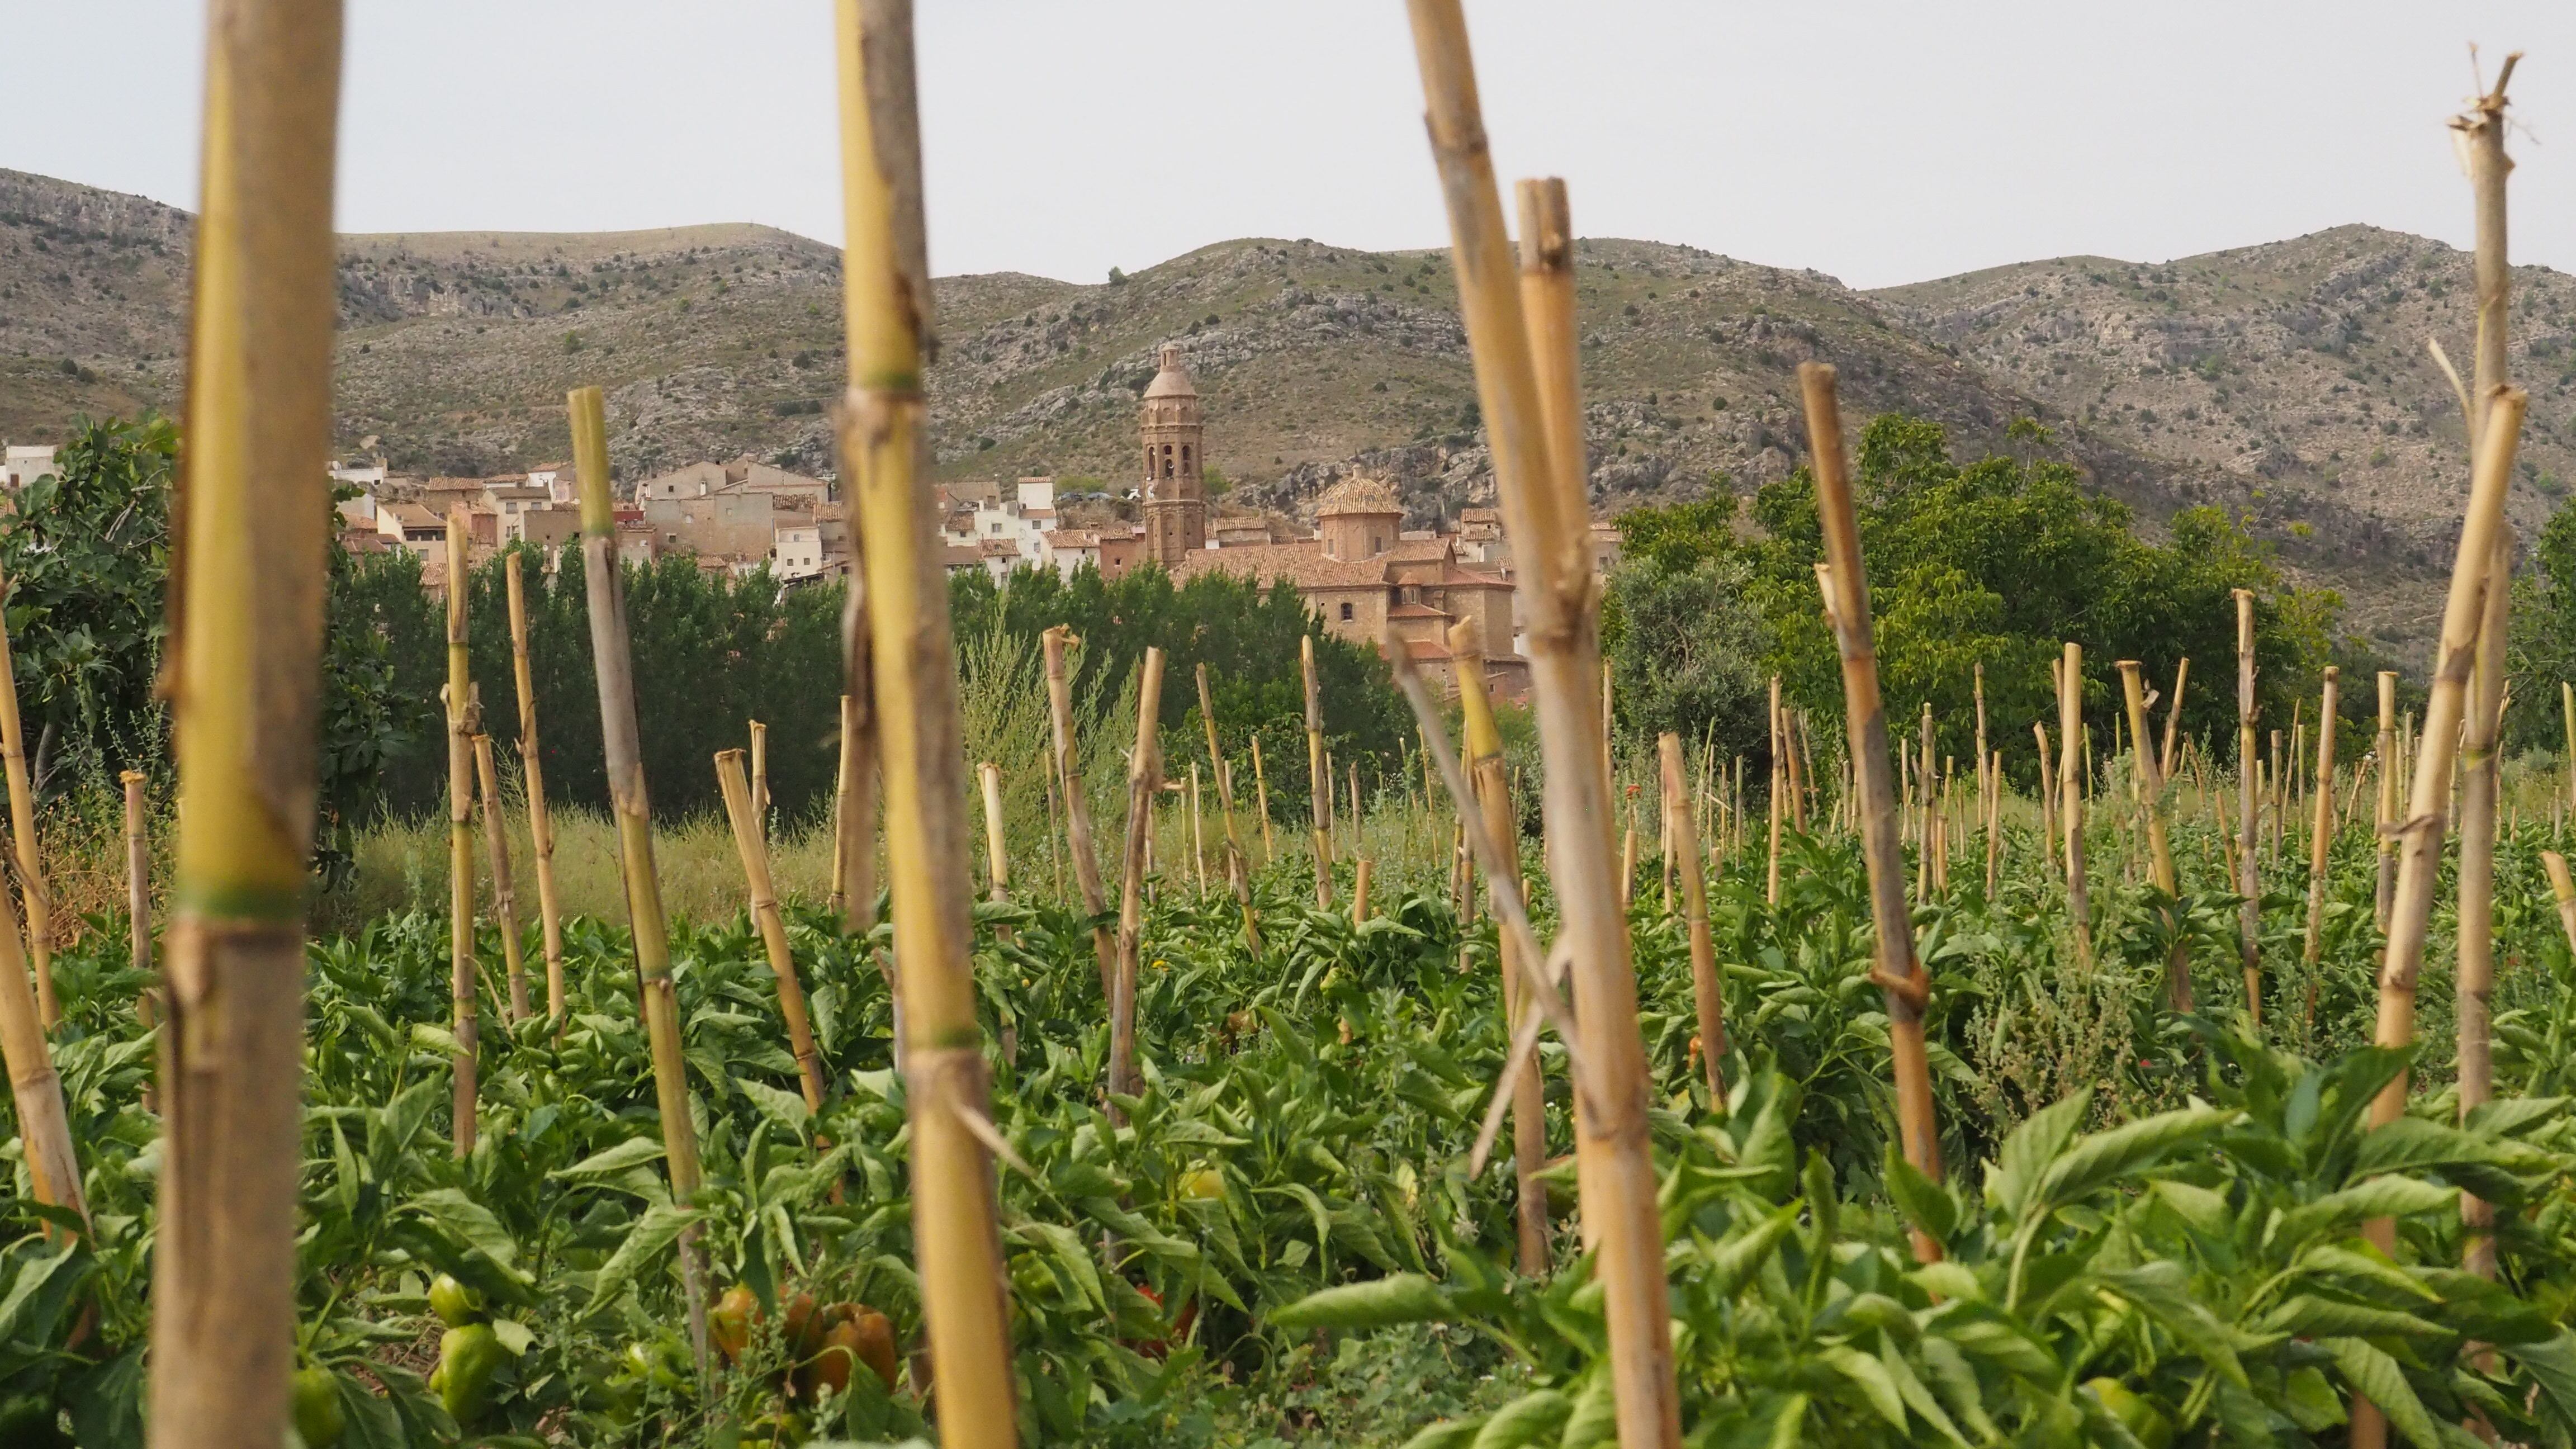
(91, 345), (1620, 696)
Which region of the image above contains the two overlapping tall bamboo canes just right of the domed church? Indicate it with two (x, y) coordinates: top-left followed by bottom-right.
(1409, 22), (1682, 1423)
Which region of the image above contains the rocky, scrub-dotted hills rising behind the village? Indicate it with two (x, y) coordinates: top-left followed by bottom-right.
(0, 170), (2576, 655)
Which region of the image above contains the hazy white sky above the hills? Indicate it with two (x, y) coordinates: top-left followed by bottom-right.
(0, 0), (2576, 286)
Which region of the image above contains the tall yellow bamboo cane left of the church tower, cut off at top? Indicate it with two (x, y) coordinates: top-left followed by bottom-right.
(837, 0), (1015, 1423)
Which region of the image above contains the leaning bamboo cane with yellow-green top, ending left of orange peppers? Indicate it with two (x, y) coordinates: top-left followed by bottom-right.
(564, 387), (708, 1366)
